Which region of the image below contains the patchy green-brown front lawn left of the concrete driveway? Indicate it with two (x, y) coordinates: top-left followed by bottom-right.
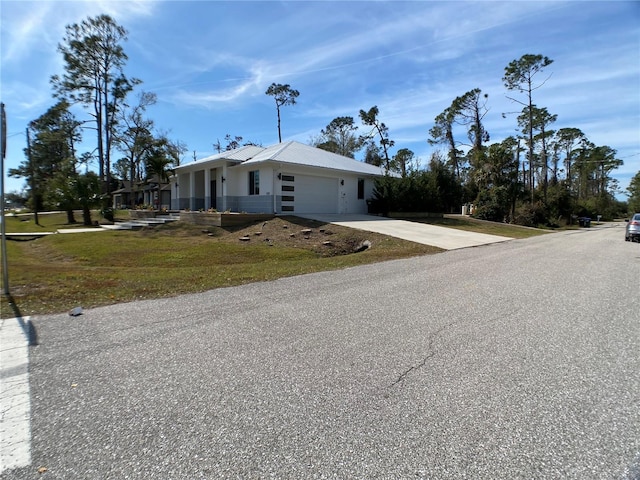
(0, 214), (441, 318)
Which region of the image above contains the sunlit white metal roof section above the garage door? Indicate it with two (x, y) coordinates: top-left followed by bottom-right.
(242, 141), (384, 175)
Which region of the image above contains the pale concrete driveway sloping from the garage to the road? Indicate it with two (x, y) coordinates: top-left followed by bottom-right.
(298, 214), (512, 250)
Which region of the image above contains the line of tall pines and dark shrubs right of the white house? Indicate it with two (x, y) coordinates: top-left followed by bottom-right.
(311, 54), (640, 225)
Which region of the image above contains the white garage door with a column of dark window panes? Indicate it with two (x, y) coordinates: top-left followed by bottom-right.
(281, 173), (338, 213)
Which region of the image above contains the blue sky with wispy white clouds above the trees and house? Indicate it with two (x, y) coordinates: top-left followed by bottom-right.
(0, 0), (640, 199)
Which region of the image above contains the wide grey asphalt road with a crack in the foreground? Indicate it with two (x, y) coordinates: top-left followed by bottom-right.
(2, 225), (640, 480)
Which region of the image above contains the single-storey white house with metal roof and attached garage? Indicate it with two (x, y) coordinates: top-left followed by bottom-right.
(171, 142), (384, 215)
